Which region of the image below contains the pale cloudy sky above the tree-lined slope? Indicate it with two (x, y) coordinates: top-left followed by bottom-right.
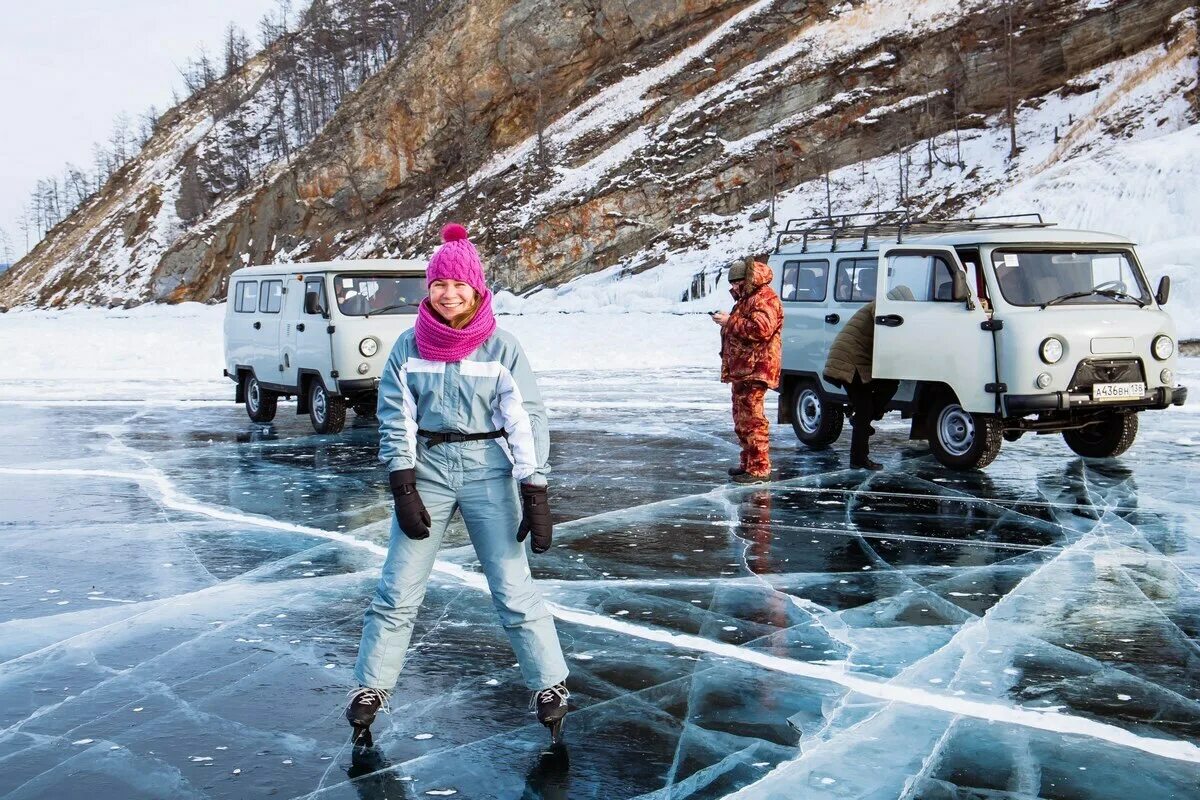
(0, 0), (279, 260)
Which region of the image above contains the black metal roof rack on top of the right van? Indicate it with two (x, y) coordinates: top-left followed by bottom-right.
(775, 209), (1055, 253)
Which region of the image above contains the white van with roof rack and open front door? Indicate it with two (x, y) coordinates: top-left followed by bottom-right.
(769, 211), (1187, 469)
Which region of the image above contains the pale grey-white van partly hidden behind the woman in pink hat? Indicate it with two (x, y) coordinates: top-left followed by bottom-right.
(224, 260), (426, 433)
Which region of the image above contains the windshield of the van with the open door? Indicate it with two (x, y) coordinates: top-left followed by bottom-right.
(991, 249), (1150, 308)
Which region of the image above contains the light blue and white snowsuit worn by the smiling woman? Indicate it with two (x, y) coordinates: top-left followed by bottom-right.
(354, 330), (568, 691)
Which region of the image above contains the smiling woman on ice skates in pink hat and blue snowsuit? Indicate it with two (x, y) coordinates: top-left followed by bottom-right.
(346, 224), (569, 745)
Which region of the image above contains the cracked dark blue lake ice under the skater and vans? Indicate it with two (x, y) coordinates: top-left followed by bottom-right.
(0, 365), (1200, 800)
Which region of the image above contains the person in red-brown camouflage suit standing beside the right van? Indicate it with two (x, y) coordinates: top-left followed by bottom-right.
(713, 258), (784, 483)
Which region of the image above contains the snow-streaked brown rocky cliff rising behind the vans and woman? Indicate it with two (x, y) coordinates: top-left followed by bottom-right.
(0, 0), (1196, 306)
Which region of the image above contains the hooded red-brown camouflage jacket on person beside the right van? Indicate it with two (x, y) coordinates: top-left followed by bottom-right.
(721, 261), (784, 389)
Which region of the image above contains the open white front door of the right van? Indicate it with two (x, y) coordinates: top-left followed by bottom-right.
(871, 245), (996, 414)
